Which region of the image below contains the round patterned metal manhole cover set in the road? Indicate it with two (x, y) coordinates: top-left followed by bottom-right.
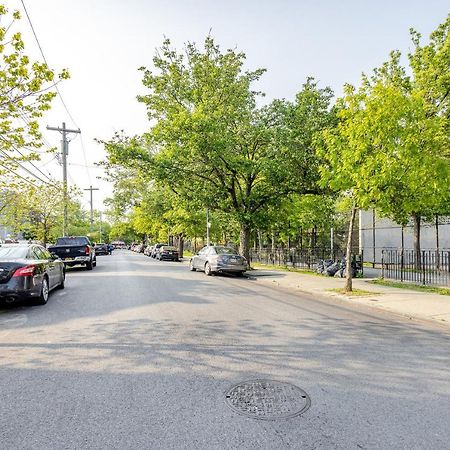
(225, 380), (311, 420)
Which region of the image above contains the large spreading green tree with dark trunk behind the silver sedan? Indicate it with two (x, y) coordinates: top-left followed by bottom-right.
(105, 37), (331, 258)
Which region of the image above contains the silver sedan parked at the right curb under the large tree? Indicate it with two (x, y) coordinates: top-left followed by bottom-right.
(189, 245), (248, 276)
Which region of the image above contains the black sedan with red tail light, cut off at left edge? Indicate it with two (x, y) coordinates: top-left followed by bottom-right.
(0, 244), (65, 305)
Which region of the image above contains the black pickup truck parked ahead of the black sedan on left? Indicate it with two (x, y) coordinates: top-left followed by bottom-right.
(48, 236), (97, 270)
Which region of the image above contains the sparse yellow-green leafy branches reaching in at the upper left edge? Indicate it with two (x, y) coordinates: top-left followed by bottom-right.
(0, 4), (68, 185)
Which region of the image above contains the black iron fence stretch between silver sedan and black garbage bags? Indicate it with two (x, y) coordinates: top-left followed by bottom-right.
(250, 247), (359, 270)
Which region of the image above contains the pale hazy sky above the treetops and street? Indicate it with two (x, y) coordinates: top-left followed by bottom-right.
(0, 0), (450, 210)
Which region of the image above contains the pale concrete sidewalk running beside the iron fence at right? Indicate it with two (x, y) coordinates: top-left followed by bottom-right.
(247, 269), (450, 326)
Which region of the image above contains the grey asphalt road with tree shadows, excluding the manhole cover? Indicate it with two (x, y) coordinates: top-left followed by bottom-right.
(0, 251), (450, 450)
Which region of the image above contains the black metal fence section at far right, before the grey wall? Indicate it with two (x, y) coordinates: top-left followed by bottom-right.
(381, 250), (450, 286)
